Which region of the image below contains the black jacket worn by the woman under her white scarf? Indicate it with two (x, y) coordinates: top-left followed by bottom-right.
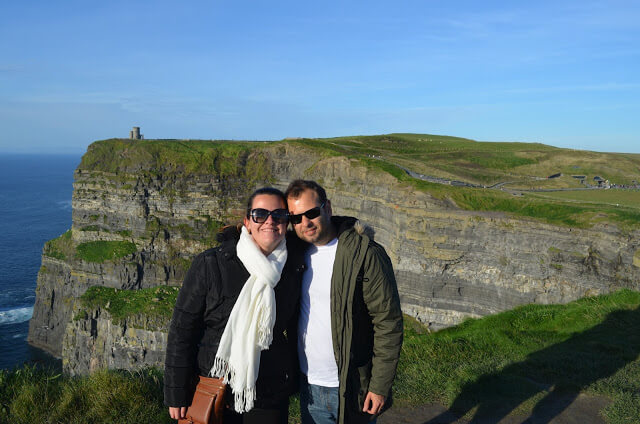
(164, 227), (305, 408)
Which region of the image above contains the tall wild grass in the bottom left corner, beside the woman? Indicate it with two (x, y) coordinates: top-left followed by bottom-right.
(0, 367), (170, 424)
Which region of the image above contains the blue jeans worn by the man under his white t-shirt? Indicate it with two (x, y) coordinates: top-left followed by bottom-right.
(300, 374), (377, 424)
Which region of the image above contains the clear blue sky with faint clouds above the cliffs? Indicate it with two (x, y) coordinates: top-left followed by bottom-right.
(0, 0), (640, 153)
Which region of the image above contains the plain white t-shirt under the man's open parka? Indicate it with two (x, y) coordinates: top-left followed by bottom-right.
(298, 238), (339, 387)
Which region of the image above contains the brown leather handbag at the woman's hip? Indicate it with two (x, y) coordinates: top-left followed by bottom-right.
(178, 376), (227, 424)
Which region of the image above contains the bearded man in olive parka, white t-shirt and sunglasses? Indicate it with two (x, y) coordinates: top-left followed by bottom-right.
(285, 180), (402, 424)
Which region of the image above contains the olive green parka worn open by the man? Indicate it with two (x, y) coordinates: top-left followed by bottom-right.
(331, 216), (403, 424)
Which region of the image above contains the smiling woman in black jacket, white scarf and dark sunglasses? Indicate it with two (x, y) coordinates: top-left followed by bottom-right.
(164, 188), (304, 424)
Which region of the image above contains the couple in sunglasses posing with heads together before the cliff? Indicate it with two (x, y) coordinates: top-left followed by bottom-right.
(164, 180), (402, 424)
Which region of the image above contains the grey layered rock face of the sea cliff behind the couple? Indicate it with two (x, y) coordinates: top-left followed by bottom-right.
(29, 138), (640, 372)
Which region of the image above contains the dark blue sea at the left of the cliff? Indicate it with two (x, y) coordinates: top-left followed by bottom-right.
(0, 154), (80, 369)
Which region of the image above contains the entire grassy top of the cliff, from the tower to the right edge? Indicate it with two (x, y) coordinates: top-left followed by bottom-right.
(79, 134), (640, 229)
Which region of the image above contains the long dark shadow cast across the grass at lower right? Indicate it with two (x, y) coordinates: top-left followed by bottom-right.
(425, 308), (640, 424)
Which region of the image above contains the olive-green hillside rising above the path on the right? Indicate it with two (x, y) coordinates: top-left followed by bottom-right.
(302, 134), (640, 188)
